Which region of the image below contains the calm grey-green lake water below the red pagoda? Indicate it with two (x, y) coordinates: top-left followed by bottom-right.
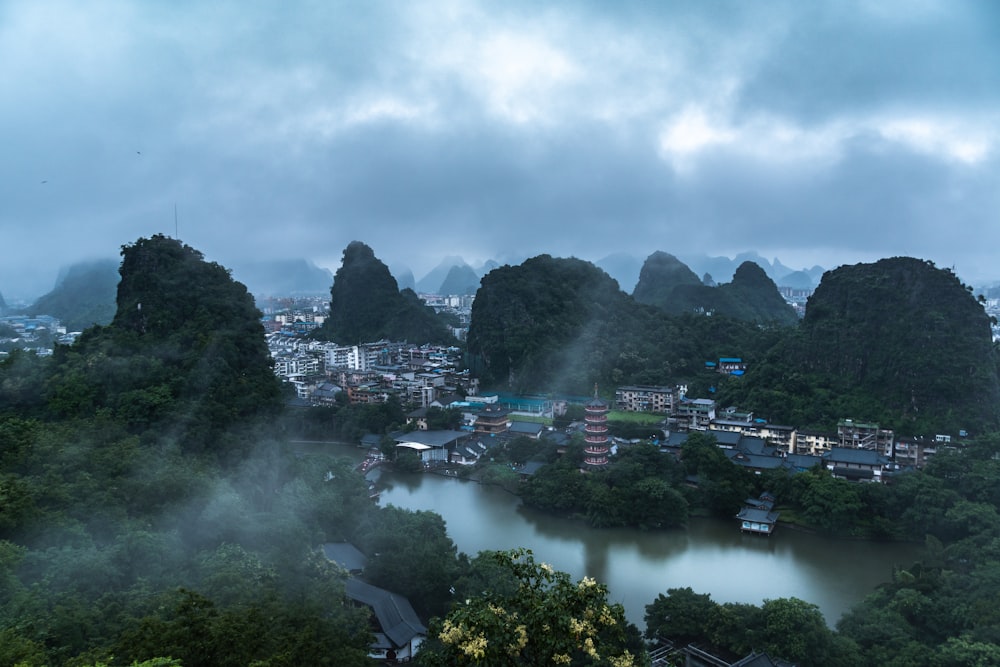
(379, 473), (918, 630)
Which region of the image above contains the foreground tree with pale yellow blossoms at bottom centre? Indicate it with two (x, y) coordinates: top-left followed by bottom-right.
(418, 549), (646, 667)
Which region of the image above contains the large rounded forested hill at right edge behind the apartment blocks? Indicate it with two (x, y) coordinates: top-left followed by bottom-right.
(722, 257), (1000, 434)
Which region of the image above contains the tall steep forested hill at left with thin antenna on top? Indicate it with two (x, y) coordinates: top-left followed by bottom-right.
(46, 235), (280, 460)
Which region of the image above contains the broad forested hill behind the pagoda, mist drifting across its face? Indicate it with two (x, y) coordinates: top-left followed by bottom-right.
(468, 255), (775, 394)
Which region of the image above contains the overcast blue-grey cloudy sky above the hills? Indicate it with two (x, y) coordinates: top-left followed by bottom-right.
(0, 0), (1000, 296)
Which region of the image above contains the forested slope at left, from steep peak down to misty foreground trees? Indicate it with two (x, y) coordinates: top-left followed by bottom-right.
(0, 236), (440, 667)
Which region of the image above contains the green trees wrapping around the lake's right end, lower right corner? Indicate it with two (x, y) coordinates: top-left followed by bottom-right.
(646, 437), (1000, 667)
